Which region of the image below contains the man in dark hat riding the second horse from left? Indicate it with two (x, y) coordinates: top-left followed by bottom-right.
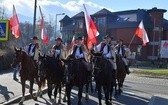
(51, 38), (65, 60)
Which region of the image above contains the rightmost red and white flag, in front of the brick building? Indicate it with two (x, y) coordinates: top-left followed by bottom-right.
(135, 20), (149, 46)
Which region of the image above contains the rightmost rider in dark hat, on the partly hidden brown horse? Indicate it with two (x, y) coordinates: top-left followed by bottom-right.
(117, 39), (130, 74)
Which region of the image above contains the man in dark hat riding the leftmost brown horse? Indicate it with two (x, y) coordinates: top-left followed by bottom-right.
(28, 36), (40, 69)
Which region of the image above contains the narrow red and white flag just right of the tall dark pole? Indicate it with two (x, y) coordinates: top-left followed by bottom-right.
(39, 6), (48, 44)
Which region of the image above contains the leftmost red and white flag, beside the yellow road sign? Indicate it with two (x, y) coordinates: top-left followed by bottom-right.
(9, 5), (20, 38)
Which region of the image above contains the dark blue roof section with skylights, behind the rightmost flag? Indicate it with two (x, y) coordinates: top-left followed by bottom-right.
(109, 9), (153, 28)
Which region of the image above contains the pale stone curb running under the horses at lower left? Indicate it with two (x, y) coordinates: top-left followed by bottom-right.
(3, 87), (47, 105)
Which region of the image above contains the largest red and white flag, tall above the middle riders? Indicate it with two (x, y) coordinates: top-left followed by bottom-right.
(83, 5), (99, 49)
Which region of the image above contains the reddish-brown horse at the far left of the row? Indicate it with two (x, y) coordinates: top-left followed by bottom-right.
(11, 48), (45, 104)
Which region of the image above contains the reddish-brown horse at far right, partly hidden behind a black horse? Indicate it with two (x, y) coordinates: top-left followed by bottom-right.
(116, 55), (126, 94)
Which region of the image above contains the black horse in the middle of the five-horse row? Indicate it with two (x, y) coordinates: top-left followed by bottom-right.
(63, 55), (91, 105)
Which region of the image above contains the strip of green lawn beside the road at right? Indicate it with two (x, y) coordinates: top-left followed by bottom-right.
(132, 69), (168, 77)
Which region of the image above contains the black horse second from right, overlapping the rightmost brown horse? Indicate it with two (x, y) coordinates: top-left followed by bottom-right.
(92, 52), (113, 105)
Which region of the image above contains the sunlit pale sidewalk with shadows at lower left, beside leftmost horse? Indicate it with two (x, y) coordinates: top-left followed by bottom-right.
(0, 70), (37, 104)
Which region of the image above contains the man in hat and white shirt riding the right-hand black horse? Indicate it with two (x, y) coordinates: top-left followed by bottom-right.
(95, 35), (117, 74)
